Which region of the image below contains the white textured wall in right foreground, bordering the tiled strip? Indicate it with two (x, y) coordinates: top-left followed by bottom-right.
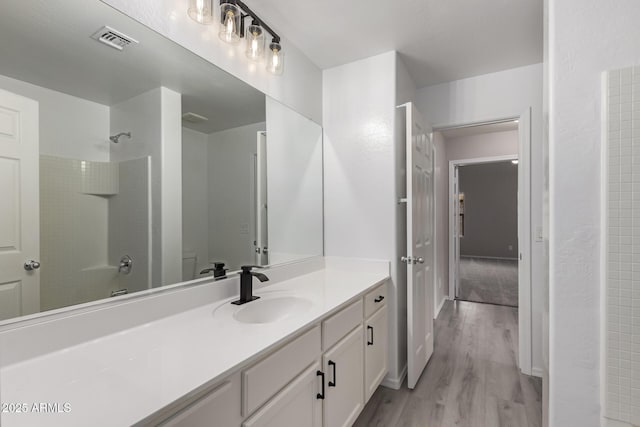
(548, 0), (640, 427)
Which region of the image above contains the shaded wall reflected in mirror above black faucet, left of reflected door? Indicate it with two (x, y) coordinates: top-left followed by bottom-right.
(207, 122), (268, 270)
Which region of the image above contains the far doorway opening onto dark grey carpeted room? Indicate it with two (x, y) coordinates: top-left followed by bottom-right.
(453, 160), (518, 307)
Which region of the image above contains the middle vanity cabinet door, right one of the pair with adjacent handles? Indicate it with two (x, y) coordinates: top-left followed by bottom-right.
(322, 324), (364, 427)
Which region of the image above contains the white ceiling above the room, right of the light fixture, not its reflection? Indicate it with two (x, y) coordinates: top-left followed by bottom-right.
(247, 0), (543, 87)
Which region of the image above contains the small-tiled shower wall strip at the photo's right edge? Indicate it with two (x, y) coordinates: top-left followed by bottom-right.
(605, 67), (640, 425)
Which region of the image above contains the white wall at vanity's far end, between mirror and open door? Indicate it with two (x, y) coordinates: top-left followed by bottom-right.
(323, 52), (406, 381)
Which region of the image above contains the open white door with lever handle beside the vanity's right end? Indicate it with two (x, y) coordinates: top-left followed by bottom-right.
(403, 103), (434, 388)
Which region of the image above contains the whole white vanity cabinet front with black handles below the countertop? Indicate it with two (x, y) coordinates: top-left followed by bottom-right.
(155, 282), (388, 427)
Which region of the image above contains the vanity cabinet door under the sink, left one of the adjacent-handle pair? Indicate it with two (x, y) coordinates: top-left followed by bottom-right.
(242, 362), (322, 427)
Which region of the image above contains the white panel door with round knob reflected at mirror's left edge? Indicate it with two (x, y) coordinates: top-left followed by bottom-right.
(0, 90), (40, 320)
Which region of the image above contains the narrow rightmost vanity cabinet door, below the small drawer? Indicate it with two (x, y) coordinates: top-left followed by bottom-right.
(364, 306), (388, 400)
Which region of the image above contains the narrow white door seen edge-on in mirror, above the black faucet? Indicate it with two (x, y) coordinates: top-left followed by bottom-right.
(255, 131), (269, 265)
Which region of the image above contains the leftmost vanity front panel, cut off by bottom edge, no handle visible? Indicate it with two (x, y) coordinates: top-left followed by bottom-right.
(160, 372), (242, 427)
